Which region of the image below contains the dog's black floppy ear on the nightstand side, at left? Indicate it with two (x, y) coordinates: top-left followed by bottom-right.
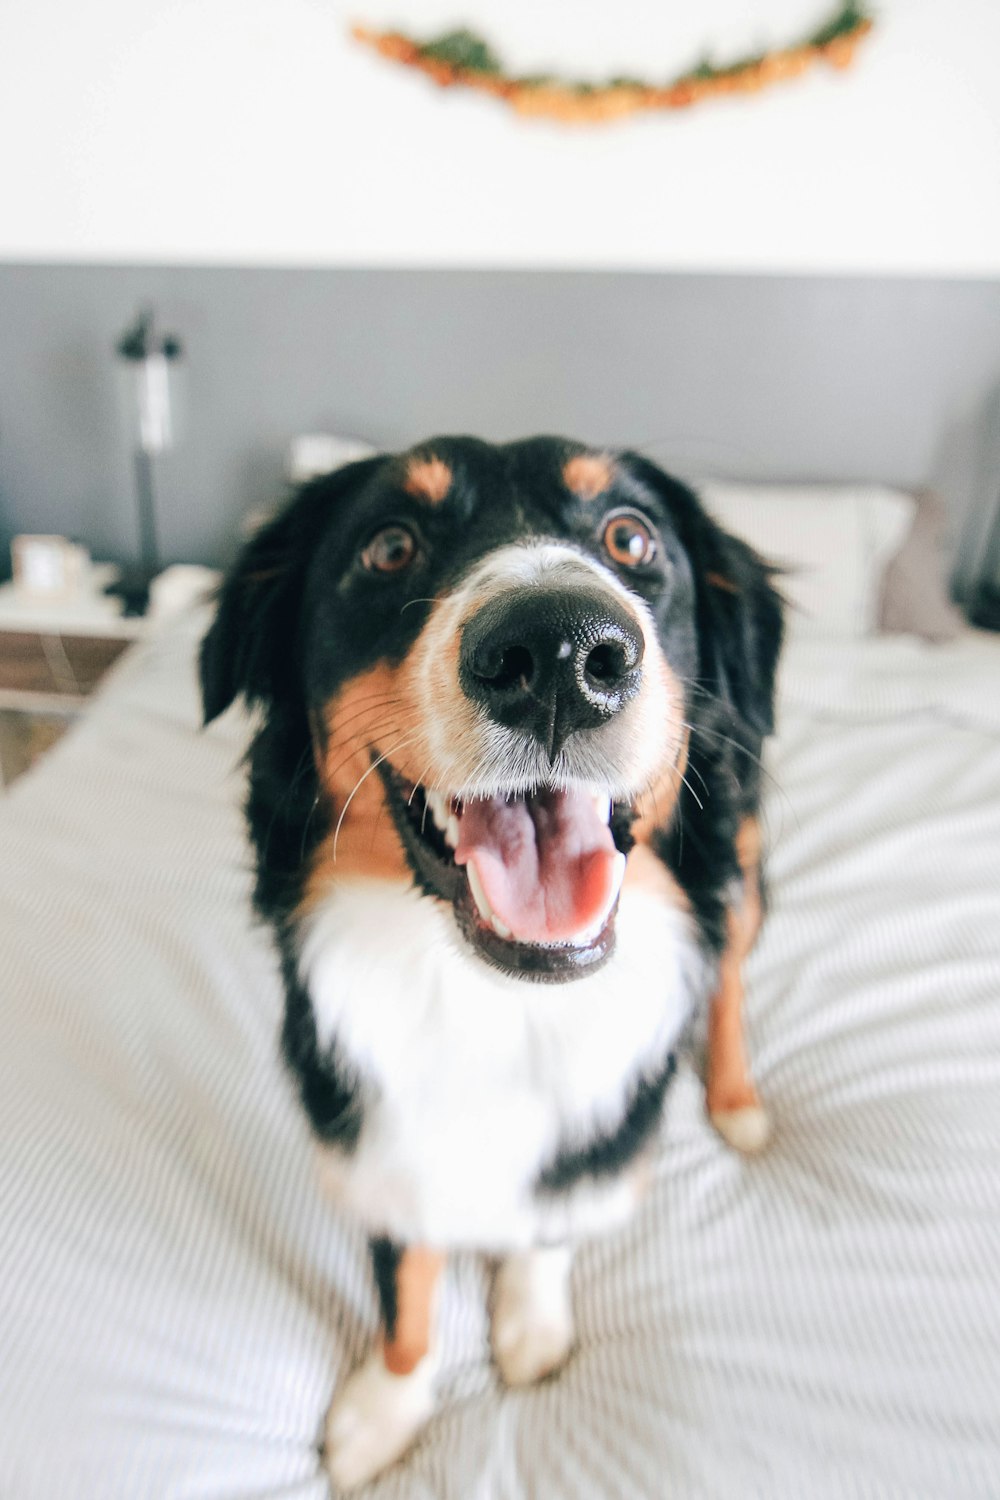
(201, 458), (381, 725)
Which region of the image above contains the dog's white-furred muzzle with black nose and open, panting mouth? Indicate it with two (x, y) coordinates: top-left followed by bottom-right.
(370, 567), (670, 980)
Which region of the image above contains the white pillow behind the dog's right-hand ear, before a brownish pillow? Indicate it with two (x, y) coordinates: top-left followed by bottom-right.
(696, 480), (915, 639)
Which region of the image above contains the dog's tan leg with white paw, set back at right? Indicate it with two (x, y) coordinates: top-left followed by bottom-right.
(708, 818), (769, 1152)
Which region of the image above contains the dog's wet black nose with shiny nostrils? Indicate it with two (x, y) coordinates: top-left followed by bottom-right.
(459, 588), (643, 761)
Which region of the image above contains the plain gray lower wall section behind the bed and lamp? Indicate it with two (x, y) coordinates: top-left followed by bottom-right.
(0, 266), (1000, 581)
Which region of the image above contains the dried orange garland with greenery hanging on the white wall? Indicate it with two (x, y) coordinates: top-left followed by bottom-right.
(352, 3), (874, 125)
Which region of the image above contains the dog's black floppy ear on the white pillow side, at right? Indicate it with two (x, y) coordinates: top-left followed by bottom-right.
(627, 455), (784, 738)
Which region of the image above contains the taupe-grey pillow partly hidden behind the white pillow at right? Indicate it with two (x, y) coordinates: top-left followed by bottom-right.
(879, 489), (966, 641)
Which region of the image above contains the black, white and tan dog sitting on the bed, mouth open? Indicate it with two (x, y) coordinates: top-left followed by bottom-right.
(201, 437), (783, 1488)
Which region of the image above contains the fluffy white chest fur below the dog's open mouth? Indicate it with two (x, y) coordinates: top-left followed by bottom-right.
(300, 881), (700, 1251)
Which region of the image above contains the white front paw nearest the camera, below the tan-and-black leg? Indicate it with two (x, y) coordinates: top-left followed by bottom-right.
(325, 1350), (435, 1493)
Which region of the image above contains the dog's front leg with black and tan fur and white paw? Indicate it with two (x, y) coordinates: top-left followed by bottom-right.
(327, 1239), (444, 1490)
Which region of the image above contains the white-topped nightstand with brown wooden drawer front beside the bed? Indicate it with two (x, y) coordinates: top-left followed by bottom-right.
(0, 564), (145, 786)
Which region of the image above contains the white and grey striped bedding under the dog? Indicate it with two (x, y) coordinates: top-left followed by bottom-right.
(0, 617), (1000, 1500)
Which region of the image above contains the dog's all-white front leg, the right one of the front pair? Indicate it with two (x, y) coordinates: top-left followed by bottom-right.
(493, 1245), (574, 1386)
